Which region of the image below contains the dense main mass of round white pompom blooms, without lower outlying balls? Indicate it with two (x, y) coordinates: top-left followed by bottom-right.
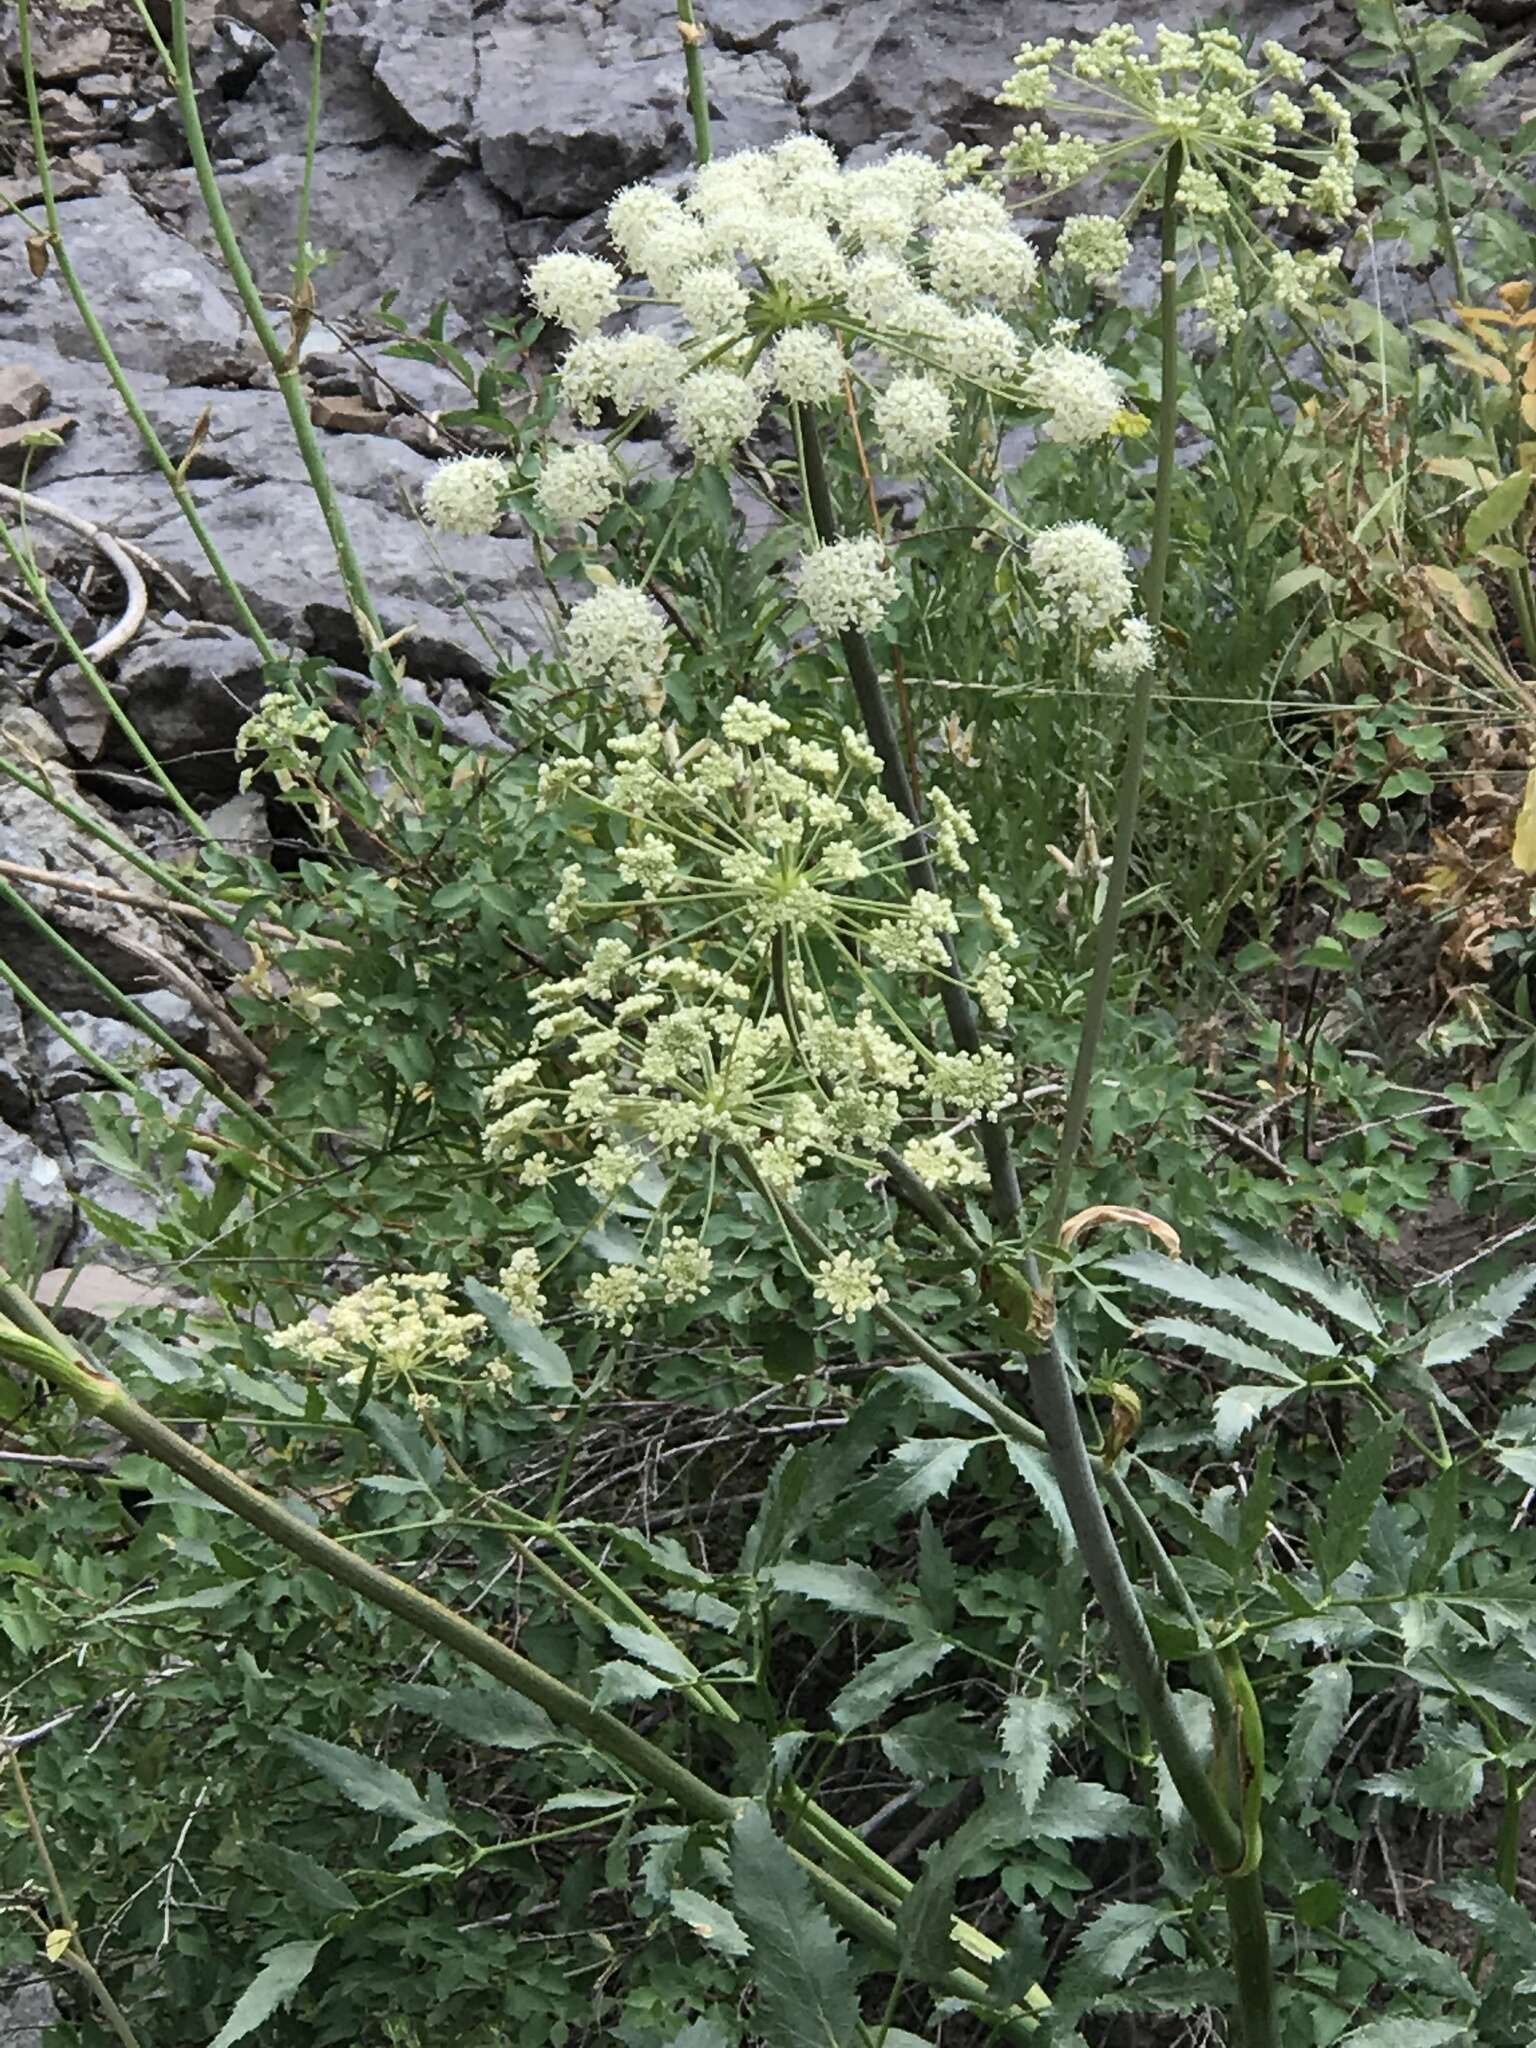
(528, 135), (1073, 463)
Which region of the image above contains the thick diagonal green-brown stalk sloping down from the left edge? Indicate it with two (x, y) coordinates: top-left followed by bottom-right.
(0, 1280), (1034, 2042)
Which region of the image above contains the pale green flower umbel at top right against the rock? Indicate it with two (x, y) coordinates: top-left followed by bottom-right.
(999, 25), (1360, 340)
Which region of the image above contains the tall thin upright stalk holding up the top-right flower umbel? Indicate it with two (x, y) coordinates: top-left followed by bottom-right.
(1042, 143), (1184, 1243)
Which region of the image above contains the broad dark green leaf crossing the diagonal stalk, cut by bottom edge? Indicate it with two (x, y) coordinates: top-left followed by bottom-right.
(731, 1806), (858, 2048)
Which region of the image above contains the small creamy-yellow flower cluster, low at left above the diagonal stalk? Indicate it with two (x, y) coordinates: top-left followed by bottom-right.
(270, 1274), (485, 1415)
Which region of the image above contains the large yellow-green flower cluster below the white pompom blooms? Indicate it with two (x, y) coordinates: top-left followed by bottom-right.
(483, 716), (1028, 1329)
